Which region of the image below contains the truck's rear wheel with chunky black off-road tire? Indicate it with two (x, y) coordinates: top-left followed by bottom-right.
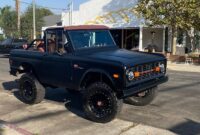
(19, 74), (45, 104)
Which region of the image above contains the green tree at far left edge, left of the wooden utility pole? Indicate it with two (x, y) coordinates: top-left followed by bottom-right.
(0, 6), (18, 37)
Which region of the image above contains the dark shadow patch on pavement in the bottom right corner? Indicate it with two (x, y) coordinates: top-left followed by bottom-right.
(169, 119), (200, 135)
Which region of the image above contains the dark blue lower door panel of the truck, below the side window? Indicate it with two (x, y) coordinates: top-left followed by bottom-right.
(41, 53), (72, 87)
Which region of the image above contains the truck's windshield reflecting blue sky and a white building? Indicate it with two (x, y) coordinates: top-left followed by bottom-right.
(68, 30), (115, 49)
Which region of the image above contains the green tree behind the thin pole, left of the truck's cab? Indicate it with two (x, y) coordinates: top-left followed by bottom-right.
(21, 5), (53, 39)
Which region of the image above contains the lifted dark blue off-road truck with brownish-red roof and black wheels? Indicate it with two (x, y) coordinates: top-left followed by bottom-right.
(10, 25), (168, 123)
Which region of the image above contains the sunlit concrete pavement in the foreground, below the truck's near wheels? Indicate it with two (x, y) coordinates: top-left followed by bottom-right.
(0, 91), (177, 135)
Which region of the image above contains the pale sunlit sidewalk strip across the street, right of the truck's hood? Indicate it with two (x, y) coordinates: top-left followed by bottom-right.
(167, 62), (200, 72)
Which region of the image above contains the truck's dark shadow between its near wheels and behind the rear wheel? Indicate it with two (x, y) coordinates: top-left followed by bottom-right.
(2, 80), (86, 119)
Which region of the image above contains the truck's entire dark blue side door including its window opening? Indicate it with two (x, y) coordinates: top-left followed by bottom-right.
(40, 29), (73, 88)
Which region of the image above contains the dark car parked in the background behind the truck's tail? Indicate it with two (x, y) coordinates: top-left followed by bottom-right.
(0, 38), (27, 53)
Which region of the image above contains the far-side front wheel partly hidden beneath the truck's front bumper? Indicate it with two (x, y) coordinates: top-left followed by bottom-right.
(124, 87), (157, 106)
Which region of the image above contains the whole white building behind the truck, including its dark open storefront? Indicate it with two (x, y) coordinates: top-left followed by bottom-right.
(61, 0), (170, 52)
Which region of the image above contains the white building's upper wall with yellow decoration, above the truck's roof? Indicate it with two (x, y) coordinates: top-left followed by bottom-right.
(62, 0), (143, 28)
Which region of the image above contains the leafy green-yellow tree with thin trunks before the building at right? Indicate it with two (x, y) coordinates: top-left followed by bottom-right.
(136, 0), (200, 54)
